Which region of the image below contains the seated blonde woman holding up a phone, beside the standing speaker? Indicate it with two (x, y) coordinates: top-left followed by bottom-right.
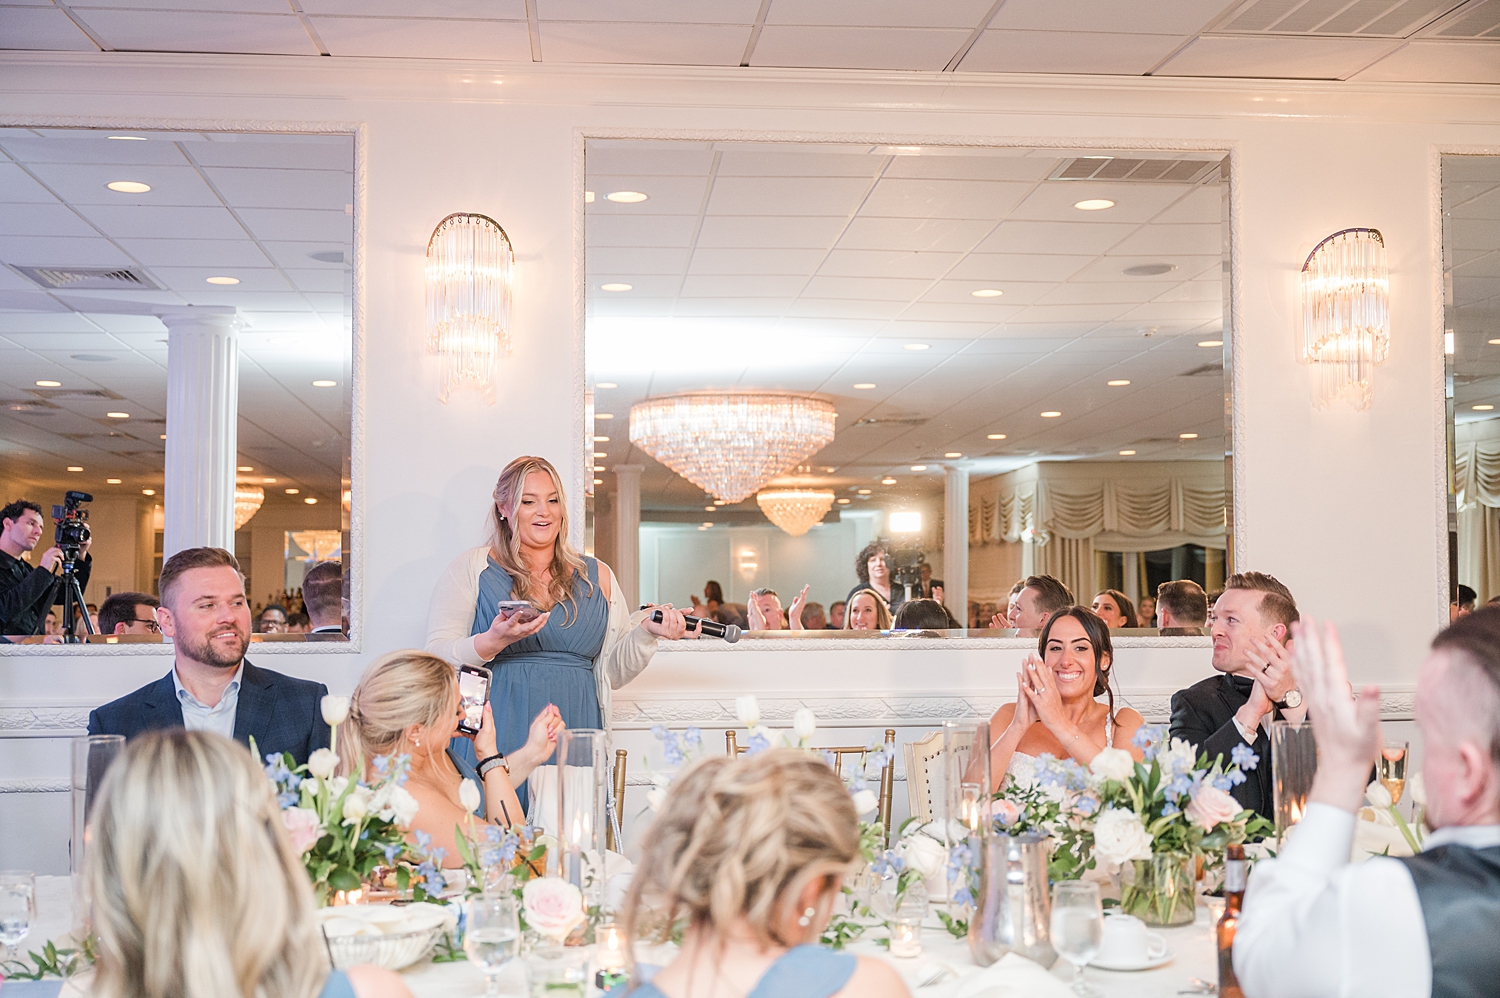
(339, 650), (563, 866)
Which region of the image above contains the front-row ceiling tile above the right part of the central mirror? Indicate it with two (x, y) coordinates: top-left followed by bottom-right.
(959, 28), (1188, 77)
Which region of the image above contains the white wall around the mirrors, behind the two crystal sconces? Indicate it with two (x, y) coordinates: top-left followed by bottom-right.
(0, 53), (1500, 866)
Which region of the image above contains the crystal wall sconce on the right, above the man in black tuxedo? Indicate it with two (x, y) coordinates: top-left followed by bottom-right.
(1302, 228), (1391, 410)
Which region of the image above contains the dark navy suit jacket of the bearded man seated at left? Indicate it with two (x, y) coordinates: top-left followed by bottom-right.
(89, 662), (329, 765)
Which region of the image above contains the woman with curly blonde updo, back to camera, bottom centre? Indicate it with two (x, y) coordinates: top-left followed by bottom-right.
(623, 749), (909, 998)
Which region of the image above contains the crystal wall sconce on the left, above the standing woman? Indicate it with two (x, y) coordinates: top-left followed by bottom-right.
(428, 212), (516, 404)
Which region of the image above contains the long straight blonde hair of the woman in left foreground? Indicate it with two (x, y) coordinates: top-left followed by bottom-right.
(84, 728), (329, 998)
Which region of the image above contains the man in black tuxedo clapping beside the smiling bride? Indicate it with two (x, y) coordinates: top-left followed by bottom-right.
(1172, 572), (1307, 821)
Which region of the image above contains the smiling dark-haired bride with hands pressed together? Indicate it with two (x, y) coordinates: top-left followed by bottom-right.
(990, 606), (1145, 792)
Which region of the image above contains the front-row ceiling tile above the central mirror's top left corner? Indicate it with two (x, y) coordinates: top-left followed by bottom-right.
(542, 21), (750, 66)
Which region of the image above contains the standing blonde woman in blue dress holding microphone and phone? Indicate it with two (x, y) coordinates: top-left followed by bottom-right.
(428, 458), (696, 804)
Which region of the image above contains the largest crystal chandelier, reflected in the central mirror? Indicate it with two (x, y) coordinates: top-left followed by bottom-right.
(630, 392), (839, 503)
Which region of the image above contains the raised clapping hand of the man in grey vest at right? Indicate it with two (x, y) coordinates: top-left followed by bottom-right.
(1292, 617), (1380, 812)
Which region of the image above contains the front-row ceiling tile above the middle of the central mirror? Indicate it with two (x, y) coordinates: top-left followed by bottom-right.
(750, 24), (969, 72)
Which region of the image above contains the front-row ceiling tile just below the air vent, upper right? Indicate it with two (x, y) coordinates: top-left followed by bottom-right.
(1155, 36), (1394, 80)
